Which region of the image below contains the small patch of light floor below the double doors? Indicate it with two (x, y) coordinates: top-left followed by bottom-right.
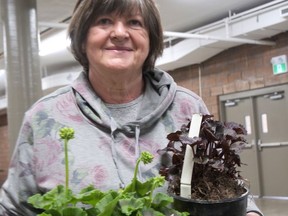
(255, 198), (288, 216)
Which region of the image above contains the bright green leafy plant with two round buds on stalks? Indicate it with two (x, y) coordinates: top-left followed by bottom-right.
(28, 127), (188, 216)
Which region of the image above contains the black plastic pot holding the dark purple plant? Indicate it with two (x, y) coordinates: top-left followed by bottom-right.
(172, 187), (249, 216)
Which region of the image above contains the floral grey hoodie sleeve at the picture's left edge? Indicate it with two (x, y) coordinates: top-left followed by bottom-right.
(0, 114), (36, 216)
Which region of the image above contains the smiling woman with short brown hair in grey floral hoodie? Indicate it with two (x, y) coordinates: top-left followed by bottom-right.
(0, 0), (264, 215)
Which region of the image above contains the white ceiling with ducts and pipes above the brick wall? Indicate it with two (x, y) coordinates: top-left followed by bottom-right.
(0, 0), (288, 109)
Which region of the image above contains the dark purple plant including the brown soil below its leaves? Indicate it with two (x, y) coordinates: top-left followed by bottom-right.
(159, 115), (247, 200)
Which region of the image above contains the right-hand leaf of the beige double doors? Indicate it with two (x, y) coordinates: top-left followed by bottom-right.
(255, 91), (288, 197)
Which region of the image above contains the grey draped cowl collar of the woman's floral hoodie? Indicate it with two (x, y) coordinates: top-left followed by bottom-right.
(72, 69), (177, 134)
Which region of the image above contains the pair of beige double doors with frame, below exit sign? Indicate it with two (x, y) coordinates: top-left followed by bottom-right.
(220, 85), (288, 197)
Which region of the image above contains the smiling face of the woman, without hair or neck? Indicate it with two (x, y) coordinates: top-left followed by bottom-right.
(85, 10), (149, 71)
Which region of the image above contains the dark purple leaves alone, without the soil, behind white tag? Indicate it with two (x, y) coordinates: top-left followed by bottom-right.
(159, 115), (247, 194)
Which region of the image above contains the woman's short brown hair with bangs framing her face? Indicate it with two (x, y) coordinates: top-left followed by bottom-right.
(68, 0), (164, 71)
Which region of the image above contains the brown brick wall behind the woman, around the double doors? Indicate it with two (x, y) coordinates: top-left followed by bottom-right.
(0, 32), (288, 185)
